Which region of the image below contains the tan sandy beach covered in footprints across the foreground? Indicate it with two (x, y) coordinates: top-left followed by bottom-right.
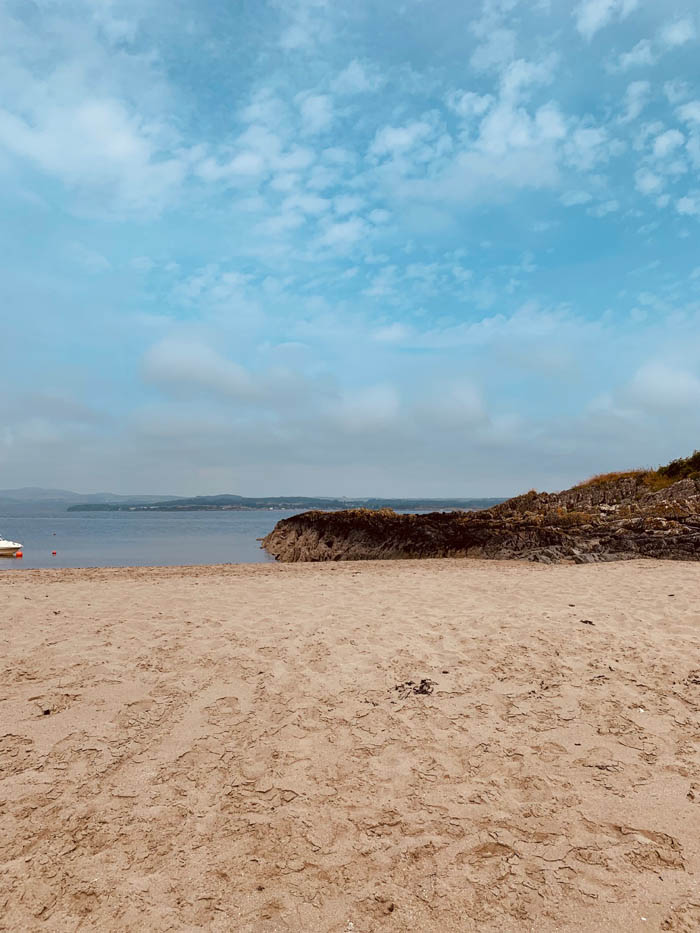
(0, 560), (700, 933)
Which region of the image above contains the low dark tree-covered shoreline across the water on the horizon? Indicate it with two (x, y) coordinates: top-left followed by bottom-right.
(67, 496), (504, 512)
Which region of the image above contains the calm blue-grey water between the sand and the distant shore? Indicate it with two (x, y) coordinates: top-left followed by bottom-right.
(0, 511), (306, 571)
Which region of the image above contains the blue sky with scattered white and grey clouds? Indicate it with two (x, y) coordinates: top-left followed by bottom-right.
(0, 0), (700, 496)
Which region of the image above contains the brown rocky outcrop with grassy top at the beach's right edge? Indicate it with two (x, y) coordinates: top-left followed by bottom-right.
(263, 471), (700, 563)
